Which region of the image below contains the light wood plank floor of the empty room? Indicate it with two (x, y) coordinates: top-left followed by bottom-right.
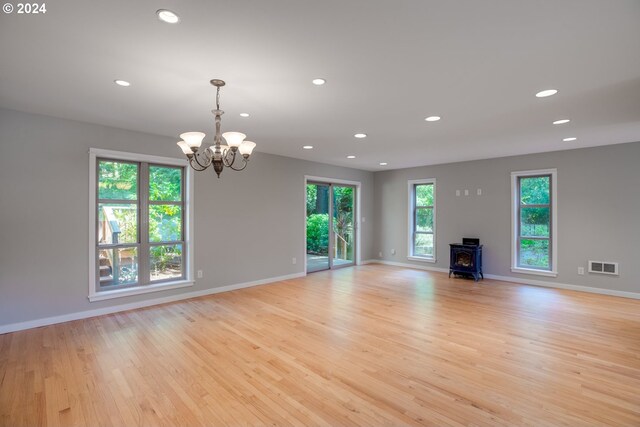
(0, 265), (640, 427)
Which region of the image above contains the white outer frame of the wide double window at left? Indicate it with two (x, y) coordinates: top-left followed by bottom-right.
(89, 148), (195, 302)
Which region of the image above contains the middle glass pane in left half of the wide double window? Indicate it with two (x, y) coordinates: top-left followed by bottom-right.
(98, 203), (138, 245)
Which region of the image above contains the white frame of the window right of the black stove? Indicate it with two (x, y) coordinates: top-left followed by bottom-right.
(511, 169), (558, 277)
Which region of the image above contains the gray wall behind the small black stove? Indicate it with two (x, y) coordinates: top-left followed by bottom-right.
(373, 142), (640, 292)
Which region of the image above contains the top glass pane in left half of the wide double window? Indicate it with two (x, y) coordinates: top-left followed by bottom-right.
(98, 160), (138, 200)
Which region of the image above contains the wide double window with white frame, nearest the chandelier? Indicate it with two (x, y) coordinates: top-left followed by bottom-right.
(89, 149), (192, 301)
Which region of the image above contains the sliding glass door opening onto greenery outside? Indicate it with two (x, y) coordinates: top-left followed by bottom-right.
(307, 182), (356, 273)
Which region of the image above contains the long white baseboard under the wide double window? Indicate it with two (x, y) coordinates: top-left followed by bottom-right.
(0, 272), (306, 334)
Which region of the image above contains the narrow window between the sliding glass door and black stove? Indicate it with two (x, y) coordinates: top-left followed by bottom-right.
(408, 179), (436, 262)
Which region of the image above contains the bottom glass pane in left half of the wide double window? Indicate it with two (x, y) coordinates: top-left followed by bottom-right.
(98, 248), (138, 286)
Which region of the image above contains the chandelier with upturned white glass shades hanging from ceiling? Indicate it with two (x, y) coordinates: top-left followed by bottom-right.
(178, 79), (256, 178)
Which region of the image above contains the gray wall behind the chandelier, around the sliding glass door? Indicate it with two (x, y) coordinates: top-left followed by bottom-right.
(0, 109), (374, 325)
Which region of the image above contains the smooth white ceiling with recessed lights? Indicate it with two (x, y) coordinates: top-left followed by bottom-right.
(0, 0), (640, 170)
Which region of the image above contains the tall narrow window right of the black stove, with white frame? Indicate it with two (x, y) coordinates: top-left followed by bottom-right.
(511, 169), (557, 276)
